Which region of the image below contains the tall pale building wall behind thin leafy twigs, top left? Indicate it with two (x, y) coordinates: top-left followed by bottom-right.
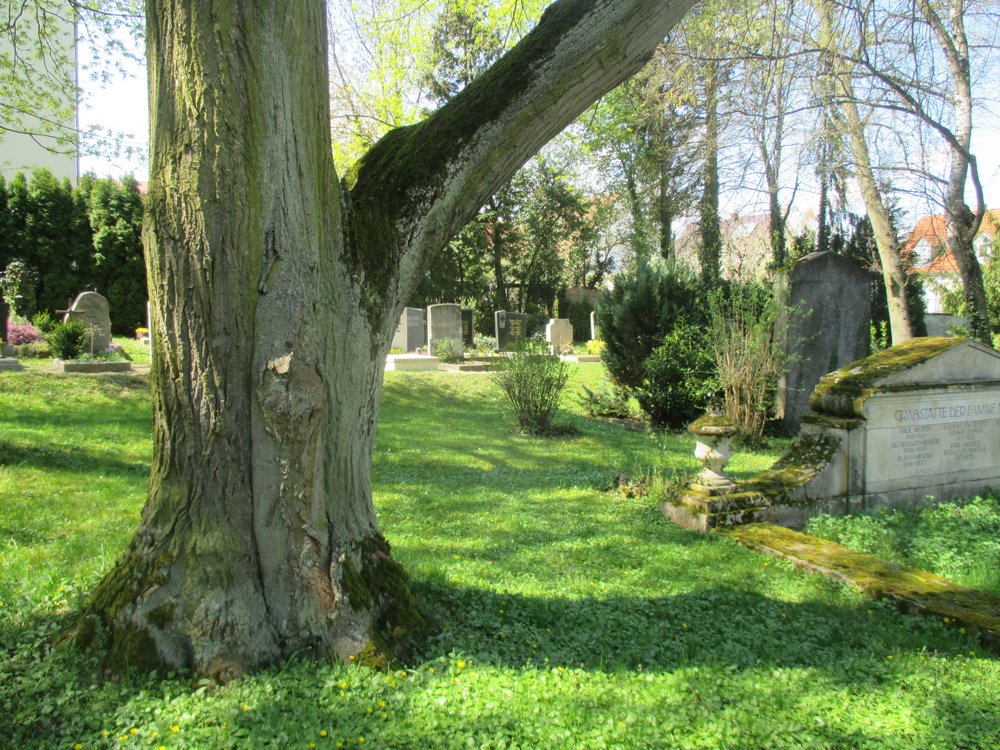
(0, 7), (79, 184)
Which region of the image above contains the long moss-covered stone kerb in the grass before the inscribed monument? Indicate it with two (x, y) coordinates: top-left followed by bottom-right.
(719, 523), (1000, 648)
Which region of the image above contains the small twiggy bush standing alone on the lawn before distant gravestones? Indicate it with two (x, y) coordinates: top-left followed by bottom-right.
(490, 342), (570, 435)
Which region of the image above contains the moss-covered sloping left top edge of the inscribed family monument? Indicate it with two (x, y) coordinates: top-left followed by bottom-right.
(809, 337), (967, 418)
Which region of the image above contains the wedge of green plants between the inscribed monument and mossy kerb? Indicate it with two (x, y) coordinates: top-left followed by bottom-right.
(806, 500), (1000, 596)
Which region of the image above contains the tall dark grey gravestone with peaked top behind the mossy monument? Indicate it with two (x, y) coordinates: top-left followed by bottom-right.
(775, 252), (871, 434)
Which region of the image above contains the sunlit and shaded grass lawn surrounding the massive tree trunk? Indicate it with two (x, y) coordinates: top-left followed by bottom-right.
(0, 365), (1000, 750)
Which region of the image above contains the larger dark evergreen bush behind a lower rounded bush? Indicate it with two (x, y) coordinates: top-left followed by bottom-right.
(597, 260), (707, 389)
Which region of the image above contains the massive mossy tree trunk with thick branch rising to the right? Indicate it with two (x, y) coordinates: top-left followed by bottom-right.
(79, 0), (691, 679)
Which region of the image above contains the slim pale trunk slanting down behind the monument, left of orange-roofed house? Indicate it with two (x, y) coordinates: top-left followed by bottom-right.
(815, 0), (913, 344)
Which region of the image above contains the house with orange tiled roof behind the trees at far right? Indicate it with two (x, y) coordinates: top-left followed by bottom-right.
(903, 209), (1000, 324)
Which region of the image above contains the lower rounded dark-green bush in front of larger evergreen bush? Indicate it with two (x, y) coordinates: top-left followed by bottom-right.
(636, 323), (720, 429)
